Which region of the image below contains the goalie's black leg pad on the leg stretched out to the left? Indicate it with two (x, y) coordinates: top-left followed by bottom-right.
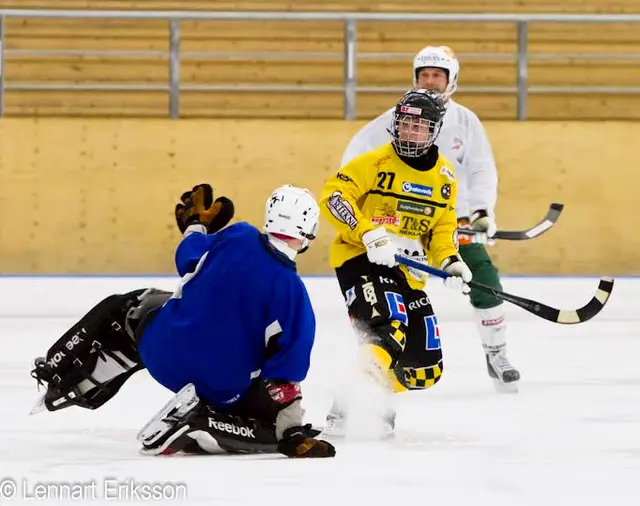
(31, 289), (170, 411)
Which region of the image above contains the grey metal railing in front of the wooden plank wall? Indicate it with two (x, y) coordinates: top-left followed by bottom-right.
(0, 9), (640, 120)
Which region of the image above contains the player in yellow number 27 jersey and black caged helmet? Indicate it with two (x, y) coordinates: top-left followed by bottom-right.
(320, 90), (471, 435)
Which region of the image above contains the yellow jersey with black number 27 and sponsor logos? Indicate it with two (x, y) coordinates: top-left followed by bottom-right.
(320, 143), (457, 289)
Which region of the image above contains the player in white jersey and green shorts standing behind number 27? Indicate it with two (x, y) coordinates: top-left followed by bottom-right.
(341, 46), (520, 391)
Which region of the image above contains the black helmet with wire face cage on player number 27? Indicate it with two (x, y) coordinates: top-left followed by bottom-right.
(389, 90), (447, 158)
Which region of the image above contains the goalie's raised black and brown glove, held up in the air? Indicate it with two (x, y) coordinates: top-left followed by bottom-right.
(175, 183), (235, 234)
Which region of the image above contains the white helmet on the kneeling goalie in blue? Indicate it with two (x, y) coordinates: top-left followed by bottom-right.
(263, 185), (320, 253)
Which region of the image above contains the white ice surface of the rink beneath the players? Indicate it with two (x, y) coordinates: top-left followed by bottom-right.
(0, 277), (640, 506)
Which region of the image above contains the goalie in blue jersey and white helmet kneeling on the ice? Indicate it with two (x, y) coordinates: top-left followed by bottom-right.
(32, 185), (335, 457)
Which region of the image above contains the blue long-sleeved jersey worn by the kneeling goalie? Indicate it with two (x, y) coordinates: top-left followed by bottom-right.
(139, 222), (316, 407)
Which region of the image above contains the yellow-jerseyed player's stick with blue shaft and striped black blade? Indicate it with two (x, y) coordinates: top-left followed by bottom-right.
(396, 255), (613, 325)
